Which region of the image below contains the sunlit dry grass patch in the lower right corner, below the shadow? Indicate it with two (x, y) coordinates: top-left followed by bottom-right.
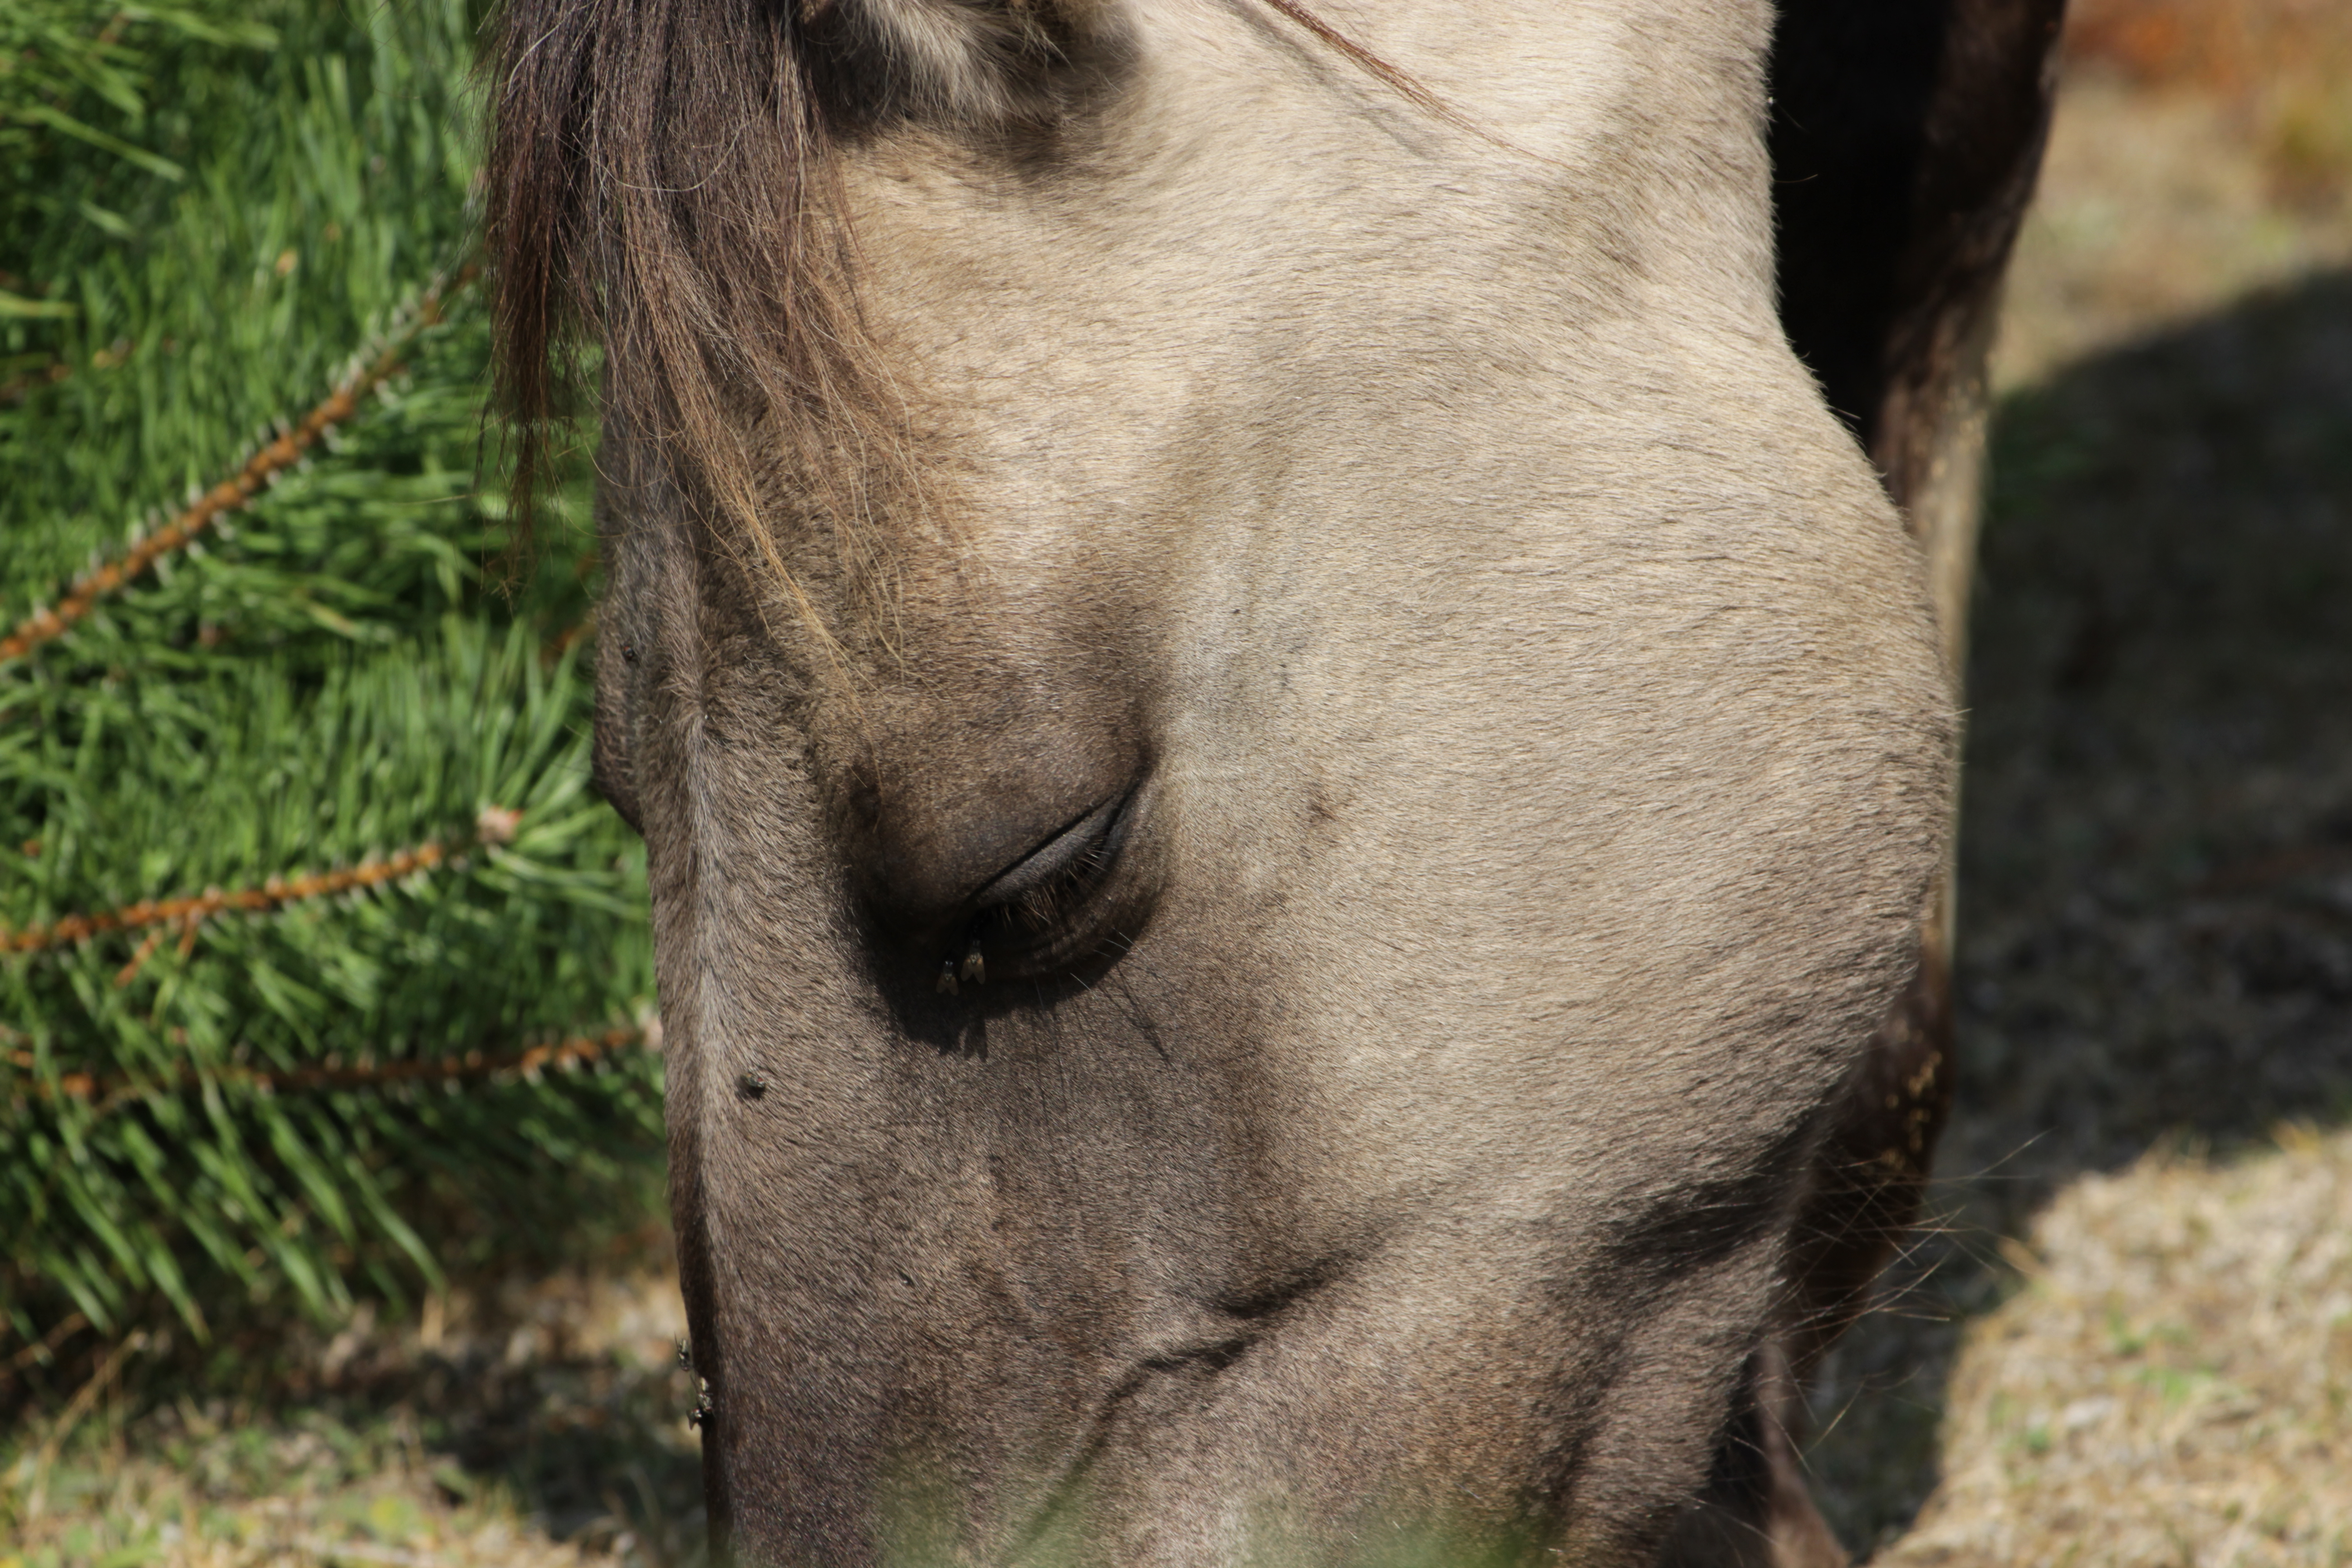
(1877, 1131), (2352, 1568)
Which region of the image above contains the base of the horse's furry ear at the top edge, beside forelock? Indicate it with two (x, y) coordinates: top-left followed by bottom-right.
(804, 0), (1117, 125)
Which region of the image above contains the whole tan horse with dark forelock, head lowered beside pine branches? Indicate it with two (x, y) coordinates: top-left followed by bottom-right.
(482, 0), (2060, 1568)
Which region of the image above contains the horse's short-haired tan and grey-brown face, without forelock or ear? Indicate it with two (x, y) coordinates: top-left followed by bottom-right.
(583, 0), (1950, 1563)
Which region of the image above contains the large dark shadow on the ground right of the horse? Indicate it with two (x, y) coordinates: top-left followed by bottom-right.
(1813, 273), (2352, 1547)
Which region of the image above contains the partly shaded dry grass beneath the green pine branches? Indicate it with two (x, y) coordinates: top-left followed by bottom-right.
(0, 1267), (703, 1568)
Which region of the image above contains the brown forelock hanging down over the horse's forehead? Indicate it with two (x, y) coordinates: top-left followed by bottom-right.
(487, 0), (877, 571)
